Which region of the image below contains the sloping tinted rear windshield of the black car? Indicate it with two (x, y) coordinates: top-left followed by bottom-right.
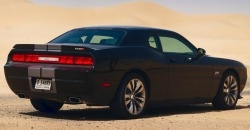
(49, 29), (125, 45)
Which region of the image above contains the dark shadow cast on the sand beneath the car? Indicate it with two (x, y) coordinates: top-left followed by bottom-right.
(20, 104), (250, 121)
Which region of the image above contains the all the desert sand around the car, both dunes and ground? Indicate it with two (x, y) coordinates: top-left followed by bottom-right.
(0, 0), (250, 129)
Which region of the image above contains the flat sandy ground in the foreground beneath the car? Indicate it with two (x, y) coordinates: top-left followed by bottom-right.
(0, 91), (250, 130)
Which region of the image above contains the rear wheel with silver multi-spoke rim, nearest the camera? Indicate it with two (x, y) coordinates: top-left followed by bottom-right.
(110, 73), (148, 118)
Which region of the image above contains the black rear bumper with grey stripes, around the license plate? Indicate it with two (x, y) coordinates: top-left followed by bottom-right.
(4, 62), (119, 105)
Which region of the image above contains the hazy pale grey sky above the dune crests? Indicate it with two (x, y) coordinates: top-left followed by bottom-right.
(32, 0), (250, 16)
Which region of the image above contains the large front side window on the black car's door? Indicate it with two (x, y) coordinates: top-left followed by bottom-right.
(159, 36), (194, 54)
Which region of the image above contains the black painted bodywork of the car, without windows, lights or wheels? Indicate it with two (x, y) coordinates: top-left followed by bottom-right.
(4, 27), (246, 105)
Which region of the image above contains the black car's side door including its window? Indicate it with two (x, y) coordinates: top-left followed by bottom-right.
(158, 34), (212, 99)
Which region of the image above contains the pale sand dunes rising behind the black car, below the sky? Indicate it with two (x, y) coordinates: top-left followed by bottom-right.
(0, 0), (250, 78)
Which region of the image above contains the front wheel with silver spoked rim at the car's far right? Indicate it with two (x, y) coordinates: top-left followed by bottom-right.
(212, 72), (239, 110)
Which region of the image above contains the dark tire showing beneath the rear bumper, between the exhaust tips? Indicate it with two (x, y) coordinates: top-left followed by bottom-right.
(30, 99), (63, 113)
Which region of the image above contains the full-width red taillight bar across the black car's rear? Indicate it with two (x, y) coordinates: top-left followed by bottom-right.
(12, 54), (94, 66)
